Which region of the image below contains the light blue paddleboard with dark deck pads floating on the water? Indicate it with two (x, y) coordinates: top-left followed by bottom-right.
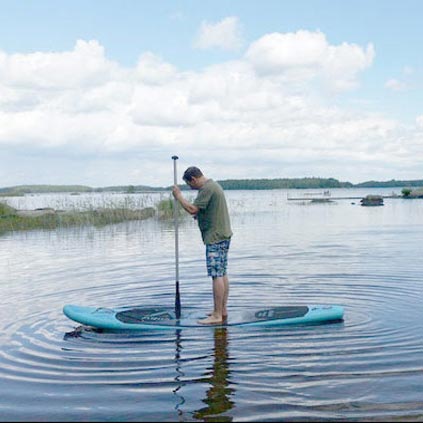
(63, 304), (344, 330)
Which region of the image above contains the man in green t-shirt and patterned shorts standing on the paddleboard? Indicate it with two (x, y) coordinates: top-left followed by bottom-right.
(173, 166), (232, 325)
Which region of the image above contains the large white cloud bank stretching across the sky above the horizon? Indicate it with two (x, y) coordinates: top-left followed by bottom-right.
(0, 31), (423, 186)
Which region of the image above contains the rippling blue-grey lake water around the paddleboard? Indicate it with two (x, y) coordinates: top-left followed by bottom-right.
(0, 189), (423, 421)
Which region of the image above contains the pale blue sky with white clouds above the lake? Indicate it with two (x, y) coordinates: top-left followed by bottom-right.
(0, 0), (423, 187)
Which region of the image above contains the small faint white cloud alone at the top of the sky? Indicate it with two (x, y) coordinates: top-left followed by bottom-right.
(194, 16), (243, 50)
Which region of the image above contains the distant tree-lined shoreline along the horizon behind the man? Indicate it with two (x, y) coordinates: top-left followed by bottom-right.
(0, 178), (423, 196)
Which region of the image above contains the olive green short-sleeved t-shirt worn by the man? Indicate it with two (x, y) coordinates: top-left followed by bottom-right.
(194, 179), (232, 244)
